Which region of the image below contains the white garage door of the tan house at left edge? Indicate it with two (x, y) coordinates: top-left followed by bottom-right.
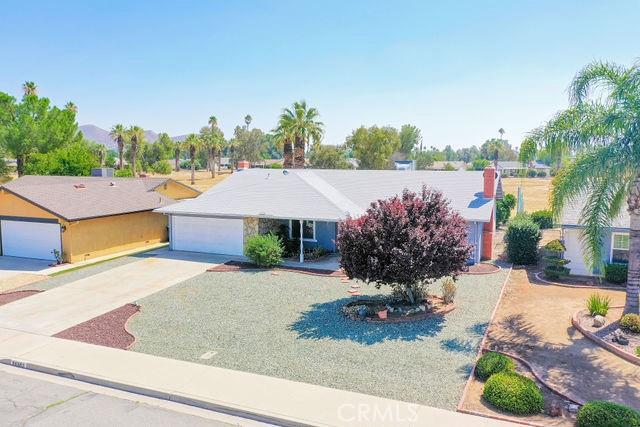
(0, 219), (62, 261)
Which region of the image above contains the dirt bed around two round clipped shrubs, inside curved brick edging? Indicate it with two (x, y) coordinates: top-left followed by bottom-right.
(461, 360), (575, 426)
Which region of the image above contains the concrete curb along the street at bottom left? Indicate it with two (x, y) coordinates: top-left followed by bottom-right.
(0, 359), (311, 427)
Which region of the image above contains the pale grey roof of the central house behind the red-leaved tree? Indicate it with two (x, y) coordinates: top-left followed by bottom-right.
(158, 169), (493, 221)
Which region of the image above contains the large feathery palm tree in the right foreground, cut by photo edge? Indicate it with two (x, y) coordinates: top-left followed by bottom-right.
(527, 62), (640, 313)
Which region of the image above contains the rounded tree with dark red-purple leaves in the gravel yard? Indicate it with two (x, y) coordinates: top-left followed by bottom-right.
(336, 186), (472, 304)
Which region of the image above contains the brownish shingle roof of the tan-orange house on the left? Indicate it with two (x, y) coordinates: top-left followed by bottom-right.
(0, 176), (175, 221)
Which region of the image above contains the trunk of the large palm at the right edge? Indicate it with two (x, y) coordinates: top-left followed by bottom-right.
(623, 174), (640, 314)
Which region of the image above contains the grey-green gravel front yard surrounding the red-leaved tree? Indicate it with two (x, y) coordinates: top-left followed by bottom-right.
(128, 270), (507, 409)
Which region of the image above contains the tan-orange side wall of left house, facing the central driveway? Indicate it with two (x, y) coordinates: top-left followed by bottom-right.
(62, 212), (168, 262)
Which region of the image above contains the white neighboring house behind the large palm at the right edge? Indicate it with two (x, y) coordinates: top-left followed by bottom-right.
(560, 200), (630, 276)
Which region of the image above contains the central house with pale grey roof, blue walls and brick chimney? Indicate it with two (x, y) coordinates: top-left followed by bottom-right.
(156, 168), (500, 263)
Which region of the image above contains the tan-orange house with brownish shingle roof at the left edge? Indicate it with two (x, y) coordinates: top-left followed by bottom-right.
(0, 176), (200, 262)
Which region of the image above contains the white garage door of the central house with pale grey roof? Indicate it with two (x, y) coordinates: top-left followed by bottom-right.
(171, 215), (244, 255)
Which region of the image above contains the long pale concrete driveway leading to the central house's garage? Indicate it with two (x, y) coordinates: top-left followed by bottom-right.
(0, 249), (231, 336)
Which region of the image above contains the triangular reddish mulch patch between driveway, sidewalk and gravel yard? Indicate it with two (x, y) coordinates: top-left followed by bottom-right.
(54, 304), (140, 349)
